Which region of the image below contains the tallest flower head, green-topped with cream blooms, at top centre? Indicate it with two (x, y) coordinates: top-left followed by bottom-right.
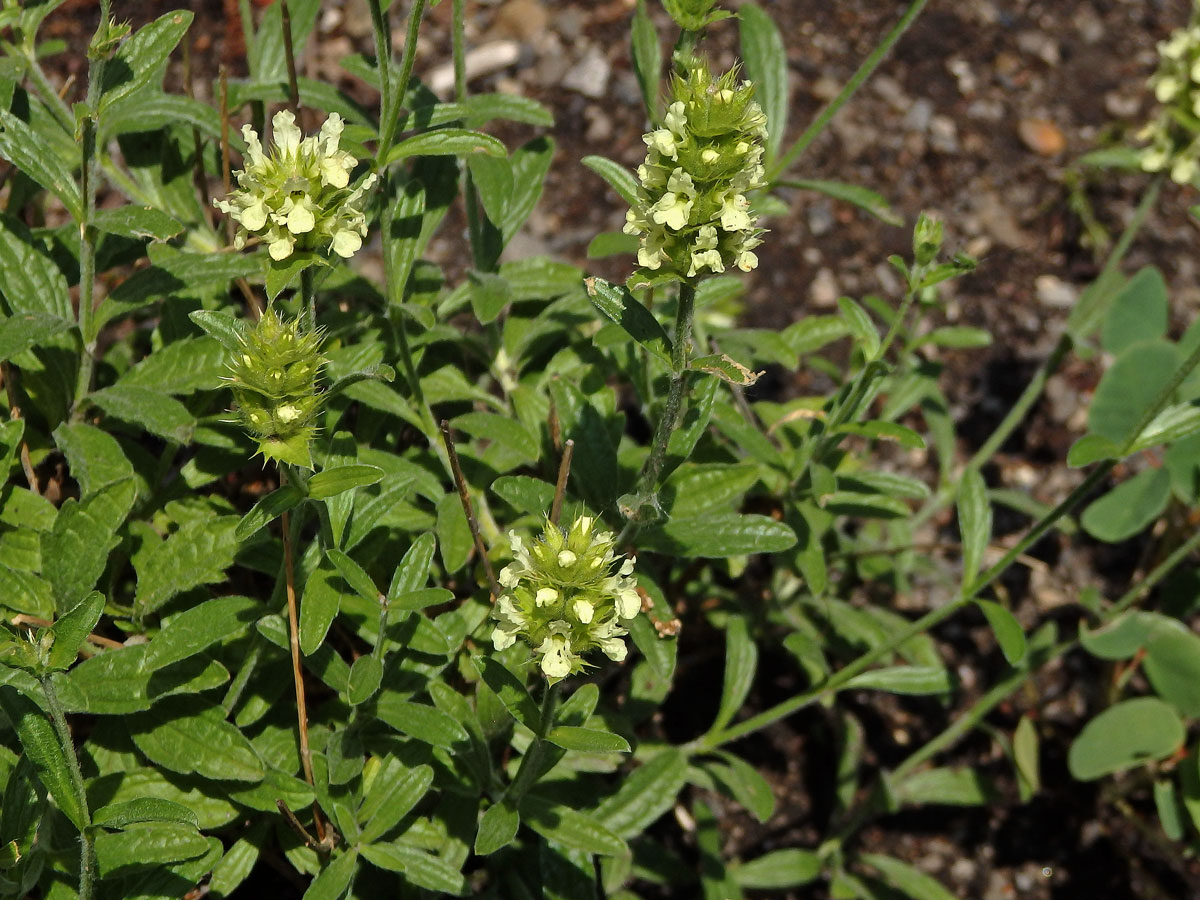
(625, 59), (767, 278)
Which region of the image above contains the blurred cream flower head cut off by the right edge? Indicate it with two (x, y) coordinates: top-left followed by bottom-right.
(1138, 4), (1200, 185)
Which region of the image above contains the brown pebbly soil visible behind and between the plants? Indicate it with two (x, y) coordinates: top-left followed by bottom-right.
(30, 0), (1200, 900)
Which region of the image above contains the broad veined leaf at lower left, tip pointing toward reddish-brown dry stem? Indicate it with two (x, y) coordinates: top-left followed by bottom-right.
(127, 697), (266, 782)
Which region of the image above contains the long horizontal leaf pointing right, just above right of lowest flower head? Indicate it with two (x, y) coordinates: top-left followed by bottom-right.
(638, 512), (796, 558)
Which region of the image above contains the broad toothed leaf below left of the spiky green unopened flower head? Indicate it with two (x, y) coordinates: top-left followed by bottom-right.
(136, 516), (238, 614)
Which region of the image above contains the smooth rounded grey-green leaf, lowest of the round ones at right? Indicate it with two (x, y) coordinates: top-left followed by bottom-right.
(1067, 697), (1184, 781)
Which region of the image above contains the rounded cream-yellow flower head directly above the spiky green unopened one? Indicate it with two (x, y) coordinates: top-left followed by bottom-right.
(214, 109), (376, 260)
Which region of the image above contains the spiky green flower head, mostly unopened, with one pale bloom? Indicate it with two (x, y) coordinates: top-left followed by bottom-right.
(227, 307), (325, 468)
